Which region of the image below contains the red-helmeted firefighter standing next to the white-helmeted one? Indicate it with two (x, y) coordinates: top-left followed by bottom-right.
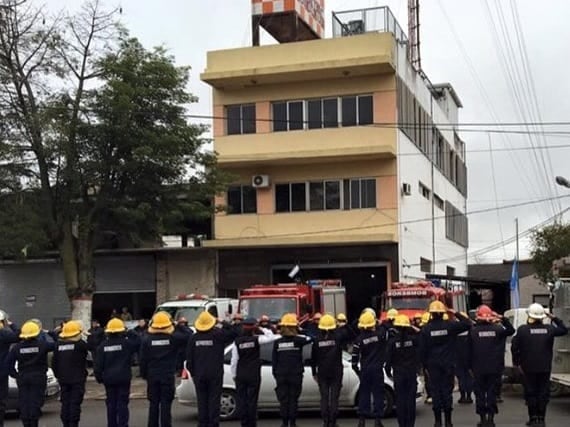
(467, 305), (515, 427)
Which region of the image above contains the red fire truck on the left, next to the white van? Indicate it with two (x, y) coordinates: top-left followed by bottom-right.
(238, 279), (346, 321)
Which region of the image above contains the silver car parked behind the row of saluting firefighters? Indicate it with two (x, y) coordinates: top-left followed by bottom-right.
(176, 343), (423, 420)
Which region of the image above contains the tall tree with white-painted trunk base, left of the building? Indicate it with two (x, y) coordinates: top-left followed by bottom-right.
(0, 0), (224, 324)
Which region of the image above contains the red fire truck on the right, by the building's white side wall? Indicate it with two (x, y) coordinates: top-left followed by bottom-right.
(381, 280), (467, 319)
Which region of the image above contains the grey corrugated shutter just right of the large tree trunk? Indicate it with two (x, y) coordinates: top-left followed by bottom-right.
(95, 255), (156, 293)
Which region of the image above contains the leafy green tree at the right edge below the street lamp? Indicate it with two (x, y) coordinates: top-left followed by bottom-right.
(531, 223), (570, 283)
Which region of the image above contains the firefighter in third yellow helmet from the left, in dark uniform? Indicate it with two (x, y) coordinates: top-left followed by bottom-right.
(94, 317), (140, 427)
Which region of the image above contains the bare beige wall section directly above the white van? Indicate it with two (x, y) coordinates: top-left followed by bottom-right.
(156, 248), (217, 304)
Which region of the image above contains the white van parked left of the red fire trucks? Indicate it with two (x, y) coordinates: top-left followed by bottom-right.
(156, 294), (238, 326)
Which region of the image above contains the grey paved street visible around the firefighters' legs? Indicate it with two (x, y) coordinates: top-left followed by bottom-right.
(6, 392), (570, 427)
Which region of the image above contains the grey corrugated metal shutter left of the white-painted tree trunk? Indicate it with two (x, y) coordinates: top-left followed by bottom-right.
(0, 262), (71, 329)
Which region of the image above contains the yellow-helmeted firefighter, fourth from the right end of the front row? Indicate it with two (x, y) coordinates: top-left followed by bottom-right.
(386, 314), (420, 427)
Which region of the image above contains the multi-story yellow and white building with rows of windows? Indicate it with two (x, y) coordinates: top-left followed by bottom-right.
(201, 0), (467, 318)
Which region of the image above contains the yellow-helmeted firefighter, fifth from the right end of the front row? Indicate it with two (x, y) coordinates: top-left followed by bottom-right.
(352, 311), (389, 427)
